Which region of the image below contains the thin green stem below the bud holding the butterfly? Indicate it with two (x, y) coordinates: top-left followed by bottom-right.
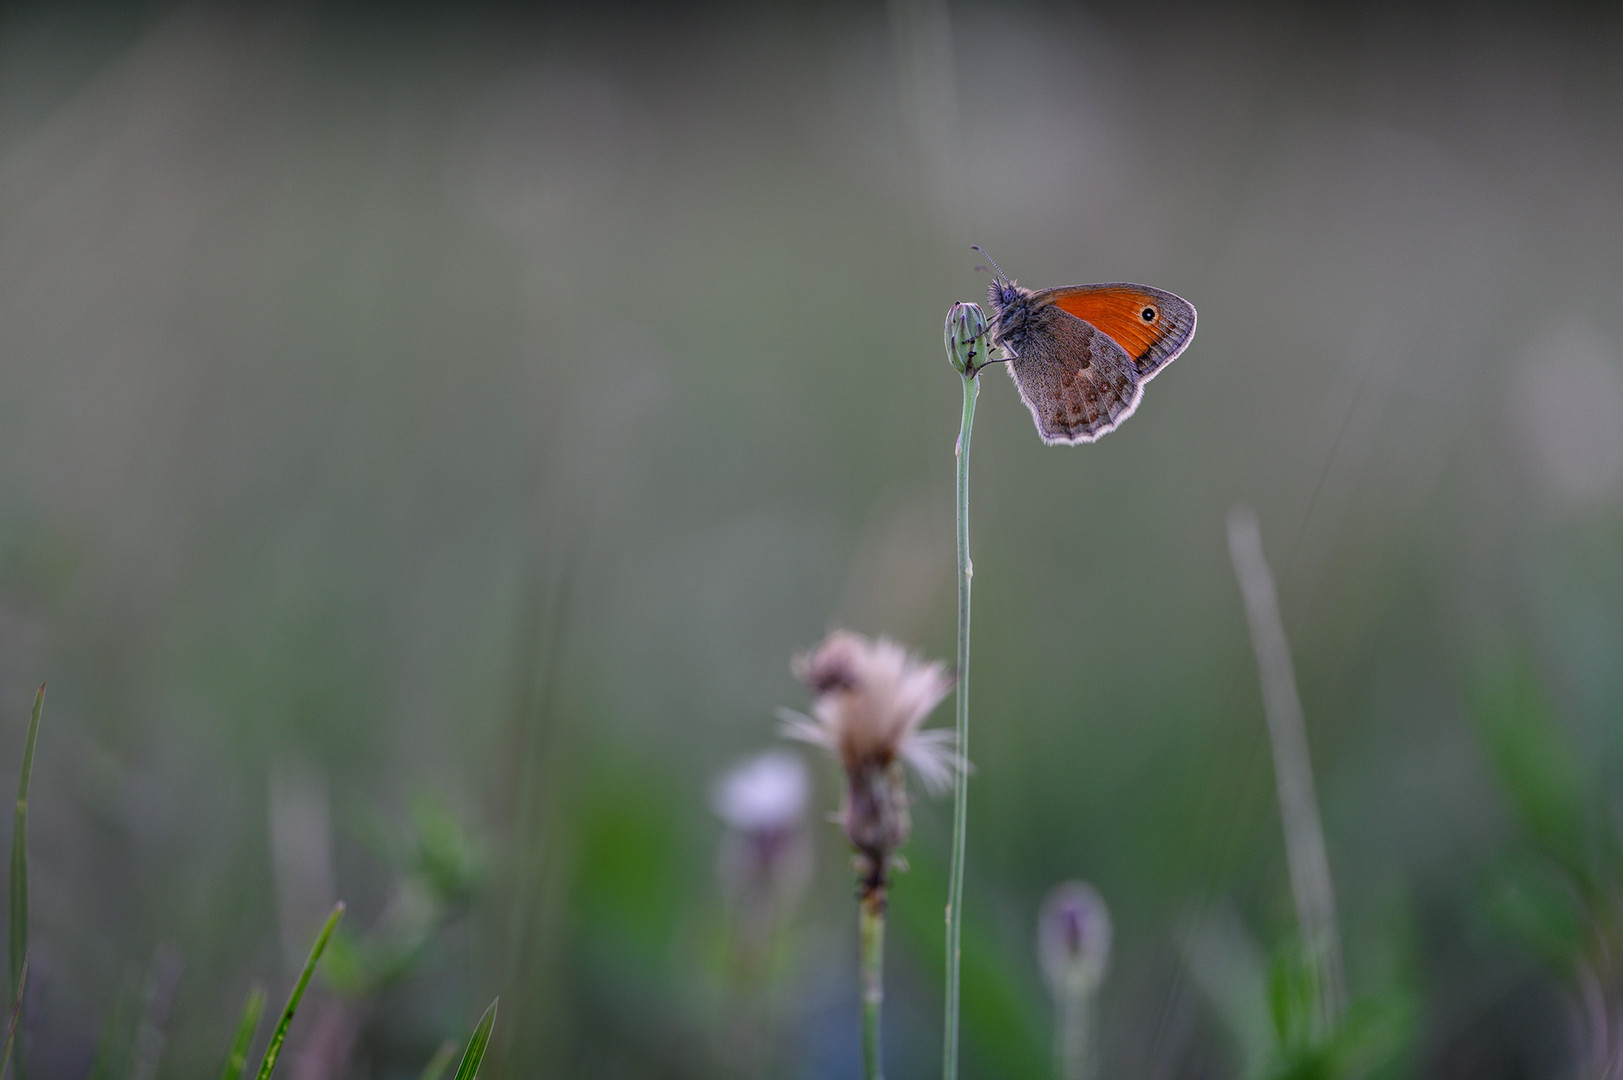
(941, 369), (980, 1080)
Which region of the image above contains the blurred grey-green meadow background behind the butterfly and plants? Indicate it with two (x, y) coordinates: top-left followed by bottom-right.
(0, 0), (1623, 1080)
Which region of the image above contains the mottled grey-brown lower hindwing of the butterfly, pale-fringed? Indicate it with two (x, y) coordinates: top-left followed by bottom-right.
(1010, 305), (1142, 443)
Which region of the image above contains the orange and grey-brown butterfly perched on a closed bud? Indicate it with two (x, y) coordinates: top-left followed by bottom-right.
(975, 247), (1195, 445)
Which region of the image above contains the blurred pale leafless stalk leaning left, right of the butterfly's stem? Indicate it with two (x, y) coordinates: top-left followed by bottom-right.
(1229, 507), (1345, 1035)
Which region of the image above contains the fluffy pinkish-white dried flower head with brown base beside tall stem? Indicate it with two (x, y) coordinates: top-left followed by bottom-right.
(786, 630), (964, 903)
